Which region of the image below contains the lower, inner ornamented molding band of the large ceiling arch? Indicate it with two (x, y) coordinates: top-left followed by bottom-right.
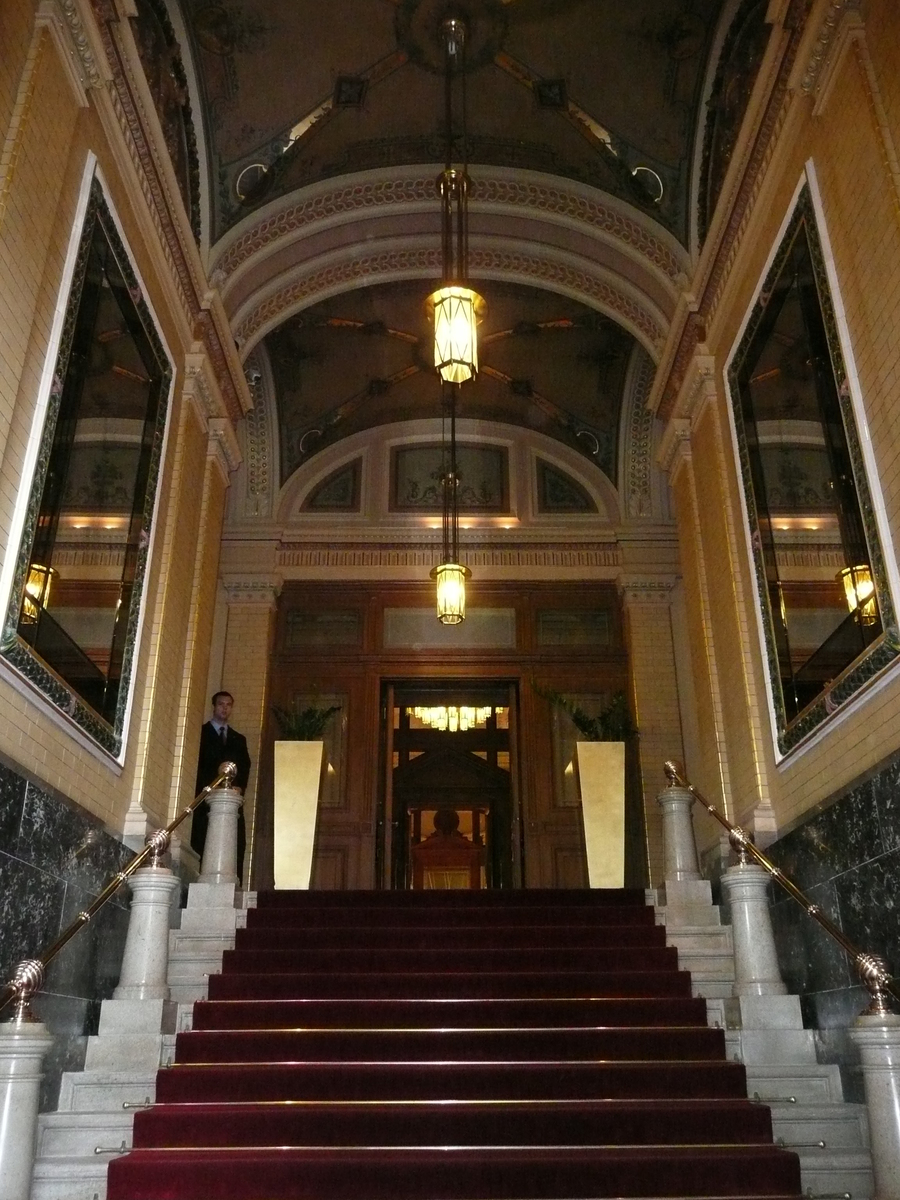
(234, 245), (666, 358)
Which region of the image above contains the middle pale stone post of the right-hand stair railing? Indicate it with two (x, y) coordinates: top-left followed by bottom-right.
(721, 863), (787, 996)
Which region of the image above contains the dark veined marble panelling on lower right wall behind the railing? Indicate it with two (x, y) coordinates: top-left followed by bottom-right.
(766, 757), (900, 1100)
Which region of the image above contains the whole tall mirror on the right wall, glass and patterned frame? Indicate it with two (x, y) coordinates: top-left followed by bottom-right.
(730, 188), (896, 750)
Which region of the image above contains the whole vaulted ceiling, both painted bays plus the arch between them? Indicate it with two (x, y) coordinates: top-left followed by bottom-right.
(169, 0), (734, 479)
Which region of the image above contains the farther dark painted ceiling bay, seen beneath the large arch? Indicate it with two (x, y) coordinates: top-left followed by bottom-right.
(264, 281), (635, 481)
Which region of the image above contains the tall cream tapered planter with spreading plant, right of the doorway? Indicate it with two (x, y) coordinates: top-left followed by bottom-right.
(534, 685), (636, 888)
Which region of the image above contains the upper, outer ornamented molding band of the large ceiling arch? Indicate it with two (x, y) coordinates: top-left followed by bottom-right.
(211, 166), (689, 295)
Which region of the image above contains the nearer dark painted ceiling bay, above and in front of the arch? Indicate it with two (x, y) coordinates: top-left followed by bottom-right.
(180, 0), (724, 241)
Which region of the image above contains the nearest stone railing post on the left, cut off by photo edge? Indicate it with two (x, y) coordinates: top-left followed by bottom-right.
(0, 1019), (53, 1200)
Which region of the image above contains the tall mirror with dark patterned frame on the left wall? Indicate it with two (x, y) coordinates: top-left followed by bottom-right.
(0, 179), (172, 754)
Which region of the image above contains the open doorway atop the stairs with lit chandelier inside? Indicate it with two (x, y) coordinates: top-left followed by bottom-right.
(379, 680), (522, 889)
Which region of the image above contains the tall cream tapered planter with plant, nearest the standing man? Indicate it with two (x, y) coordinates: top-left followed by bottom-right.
(272, 700), (341, 889)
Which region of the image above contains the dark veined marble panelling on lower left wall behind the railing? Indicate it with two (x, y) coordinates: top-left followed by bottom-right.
(0, 763), (133, 1111)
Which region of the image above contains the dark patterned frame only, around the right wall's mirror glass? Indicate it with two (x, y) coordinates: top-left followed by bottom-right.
(725, 180), (900, 756)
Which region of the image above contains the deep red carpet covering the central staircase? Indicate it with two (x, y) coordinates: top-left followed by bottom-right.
(108, 892), (800, 1200)
